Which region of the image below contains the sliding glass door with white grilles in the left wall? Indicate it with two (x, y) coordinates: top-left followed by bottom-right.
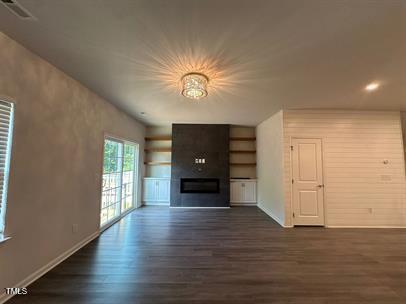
(100, 138), (139, 227)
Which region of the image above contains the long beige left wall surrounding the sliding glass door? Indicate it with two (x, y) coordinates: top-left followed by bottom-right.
(0, 33), (145, 296)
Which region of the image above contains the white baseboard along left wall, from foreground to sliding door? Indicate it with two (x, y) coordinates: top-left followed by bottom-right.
(0, 231), (100, 304)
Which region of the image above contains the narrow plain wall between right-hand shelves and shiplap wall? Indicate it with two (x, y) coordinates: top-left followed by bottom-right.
(256, 111), (286, 226)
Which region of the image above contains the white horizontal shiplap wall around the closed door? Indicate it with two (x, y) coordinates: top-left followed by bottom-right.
(284, 110), (406, 227)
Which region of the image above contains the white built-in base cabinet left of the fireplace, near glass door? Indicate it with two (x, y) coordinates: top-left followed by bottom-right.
(142, 177), (170, 205)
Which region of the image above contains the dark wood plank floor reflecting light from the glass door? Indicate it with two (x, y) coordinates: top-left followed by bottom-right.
(8, 207), (406, 304)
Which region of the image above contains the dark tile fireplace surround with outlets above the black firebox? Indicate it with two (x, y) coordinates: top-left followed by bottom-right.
(171, 124), (230, 207)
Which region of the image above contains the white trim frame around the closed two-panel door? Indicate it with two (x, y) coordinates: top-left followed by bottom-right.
(289, 136), (328, 228)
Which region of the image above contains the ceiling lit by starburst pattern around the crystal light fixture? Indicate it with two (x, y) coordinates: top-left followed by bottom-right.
(0, 0), (406, 125)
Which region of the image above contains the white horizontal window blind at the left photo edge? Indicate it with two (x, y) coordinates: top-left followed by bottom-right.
(0, 100), (14, 239)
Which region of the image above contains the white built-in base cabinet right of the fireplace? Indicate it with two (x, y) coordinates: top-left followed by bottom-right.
(230, 179), (257, 206)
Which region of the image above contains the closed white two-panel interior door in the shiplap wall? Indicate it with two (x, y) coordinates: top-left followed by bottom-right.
(292, 138), (324, 226)
